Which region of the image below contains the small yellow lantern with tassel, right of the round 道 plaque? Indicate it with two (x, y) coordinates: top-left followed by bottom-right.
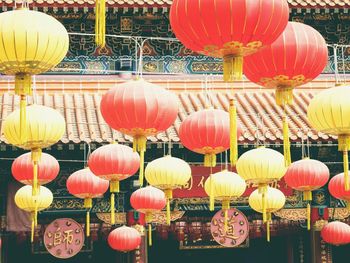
(249, 187), (286, 242)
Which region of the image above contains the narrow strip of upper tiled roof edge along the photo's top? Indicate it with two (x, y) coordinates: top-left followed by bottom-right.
(0, 0), (350, 8)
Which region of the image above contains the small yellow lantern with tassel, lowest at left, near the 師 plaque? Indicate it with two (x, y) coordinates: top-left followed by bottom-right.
(15, 185), (53, 242)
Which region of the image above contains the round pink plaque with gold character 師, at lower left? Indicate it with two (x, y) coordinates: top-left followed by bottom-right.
(44, 218), (85, 258)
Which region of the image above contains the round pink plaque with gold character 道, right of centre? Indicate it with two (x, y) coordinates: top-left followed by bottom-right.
(210, 208), (249, 247)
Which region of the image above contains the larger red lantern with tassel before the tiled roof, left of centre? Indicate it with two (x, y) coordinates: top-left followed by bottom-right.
(100, 79), (178, 186)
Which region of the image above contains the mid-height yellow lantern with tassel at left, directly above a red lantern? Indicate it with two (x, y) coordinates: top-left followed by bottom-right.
(3, 104), (66, 195)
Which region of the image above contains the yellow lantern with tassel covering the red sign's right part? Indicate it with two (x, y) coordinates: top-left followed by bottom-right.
(237, 147), (286, 223)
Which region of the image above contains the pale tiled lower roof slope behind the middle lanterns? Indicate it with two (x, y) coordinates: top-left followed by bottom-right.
(0, 75), (336, 144)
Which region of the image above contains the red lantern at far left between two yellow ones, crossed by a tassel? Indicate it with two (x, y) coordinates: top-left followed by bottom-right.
(12, 153), (60, 185)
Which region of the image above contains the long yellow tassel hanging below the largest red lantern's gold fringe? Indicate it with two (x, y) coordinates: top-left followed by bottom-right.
(229, 100), (238, 166)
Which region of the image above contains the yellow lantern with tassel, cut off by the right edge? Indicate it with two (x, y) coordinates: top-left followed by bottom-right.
(307, 85), (350, 191)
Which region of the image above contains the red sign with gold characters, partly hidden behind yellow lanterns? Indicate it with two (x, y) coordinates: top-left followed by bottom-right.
(173, 166), (293, 198)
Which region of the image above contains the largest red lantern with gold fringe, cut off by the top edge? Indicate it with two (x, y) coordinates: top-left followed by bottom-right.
(170, 0), (289, 81)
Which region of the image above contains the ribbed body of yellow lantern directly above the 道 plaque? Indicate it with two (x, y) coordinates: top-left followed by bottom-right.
(204, 171), (246, 200)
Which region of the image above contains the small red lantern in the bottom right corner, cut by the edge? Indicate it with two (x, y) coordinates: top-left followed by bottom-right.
(321, 221), (350, 246)
